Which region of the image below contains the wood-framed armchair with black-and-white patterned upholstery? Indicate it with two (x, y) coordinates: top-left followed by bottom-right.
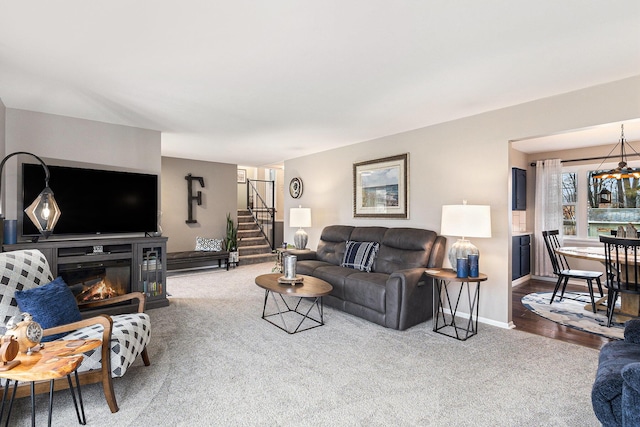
(0, 250), (151, 412)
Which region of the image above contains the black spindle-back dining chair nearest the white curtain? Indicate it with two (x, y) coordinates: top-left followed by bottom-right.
(542, 230), (603, 313)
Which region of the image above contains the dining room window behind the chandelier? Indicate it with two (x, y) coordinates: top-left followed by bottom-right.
(562, 162), (640, 238)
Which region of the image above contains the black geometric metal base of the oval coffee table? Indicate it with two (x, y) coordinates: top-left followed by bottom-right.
(262, 290), (324, 334)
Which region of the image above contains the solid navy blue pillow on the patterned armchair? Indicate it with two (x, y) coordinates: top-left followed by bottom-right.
(15, 277), (82, 342)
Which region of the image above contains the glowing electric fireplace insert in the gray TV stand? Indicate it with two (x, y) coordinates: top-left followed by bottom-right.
(58, 259), (131, 310)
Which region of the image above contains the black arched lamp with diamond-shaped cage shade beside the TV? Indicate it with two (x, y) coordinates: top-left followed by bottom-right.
(0, 151), (62, 252)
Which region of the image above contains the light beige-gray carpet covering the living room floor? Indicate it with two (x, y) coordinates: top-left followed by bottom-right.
(7, 263), (599, 427)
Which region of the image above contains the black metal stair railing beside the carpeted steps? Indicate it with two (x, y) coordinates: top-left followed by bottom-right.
(247, 179), (276, 250)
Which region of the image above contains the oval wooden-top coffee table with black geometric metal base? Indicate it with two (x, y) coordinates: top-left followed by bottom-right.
(256, 273), (333, 334)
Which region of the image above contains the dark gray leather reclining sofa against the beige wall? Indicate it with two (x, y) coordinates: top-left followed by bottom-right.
(288, 225), (446, 330)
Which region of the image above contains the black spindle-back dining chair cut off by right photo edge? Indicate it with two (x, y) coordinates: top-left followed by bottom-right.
(600, 236), (640, 326)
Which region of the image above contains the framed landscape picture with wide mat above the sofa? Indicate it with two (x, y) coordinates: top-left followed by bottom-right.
(353, 153), (409, 219)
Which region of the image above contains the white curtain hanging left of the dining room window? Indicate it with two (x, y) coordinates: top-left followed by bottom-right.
(533, 159), (562, 276)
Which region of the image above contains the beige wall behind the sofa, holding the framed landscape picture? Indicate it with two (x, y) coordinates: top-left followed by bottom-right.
(284, 75), (640, 327)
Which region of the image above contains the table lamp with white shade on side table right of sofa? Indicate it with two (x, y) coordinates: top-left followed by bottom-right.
(440, 200), (491, 277)
